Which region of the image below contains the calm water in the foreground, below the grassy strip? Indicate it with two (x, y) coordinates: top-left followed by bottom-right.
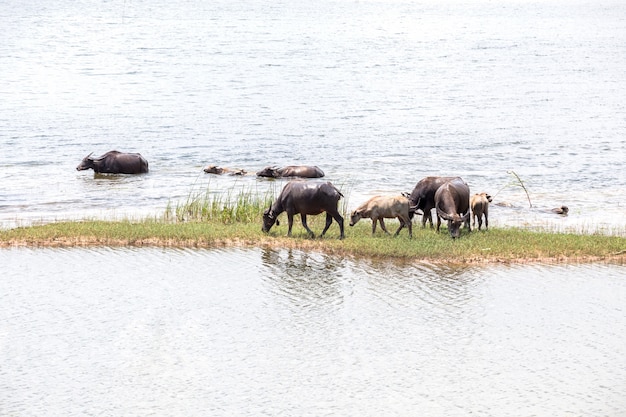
(0, 248), (626, 416)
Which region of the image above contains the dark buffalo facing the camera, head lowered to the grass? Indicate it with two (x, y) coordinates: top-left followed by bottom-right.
(435, 177), (472, 239)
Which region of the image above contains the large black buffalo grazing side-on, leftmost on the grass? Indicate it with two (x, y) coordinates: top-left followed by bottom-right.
(262, 180), (344, 239)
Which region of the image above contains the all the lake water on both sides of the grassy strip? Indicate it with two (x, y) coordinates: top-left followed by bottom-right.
(0, 0), (626, 416)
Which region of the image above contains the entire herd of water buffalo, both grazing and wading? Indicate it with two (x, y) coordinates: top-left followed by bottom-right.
(76, 151), (567, 239)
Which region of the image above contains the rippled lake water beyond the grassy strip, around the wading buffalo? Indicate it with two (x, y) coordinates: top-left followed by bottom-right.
(0, 0), (626, 234)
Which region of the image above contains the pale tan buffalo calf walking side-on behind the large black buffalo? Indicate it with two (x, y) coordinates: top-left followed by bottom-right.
(350, 195), (413, 237)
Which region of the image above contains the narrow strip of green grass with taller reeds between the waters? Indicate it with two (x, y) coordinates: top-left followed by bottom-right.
(0, 186), (626, 262)
